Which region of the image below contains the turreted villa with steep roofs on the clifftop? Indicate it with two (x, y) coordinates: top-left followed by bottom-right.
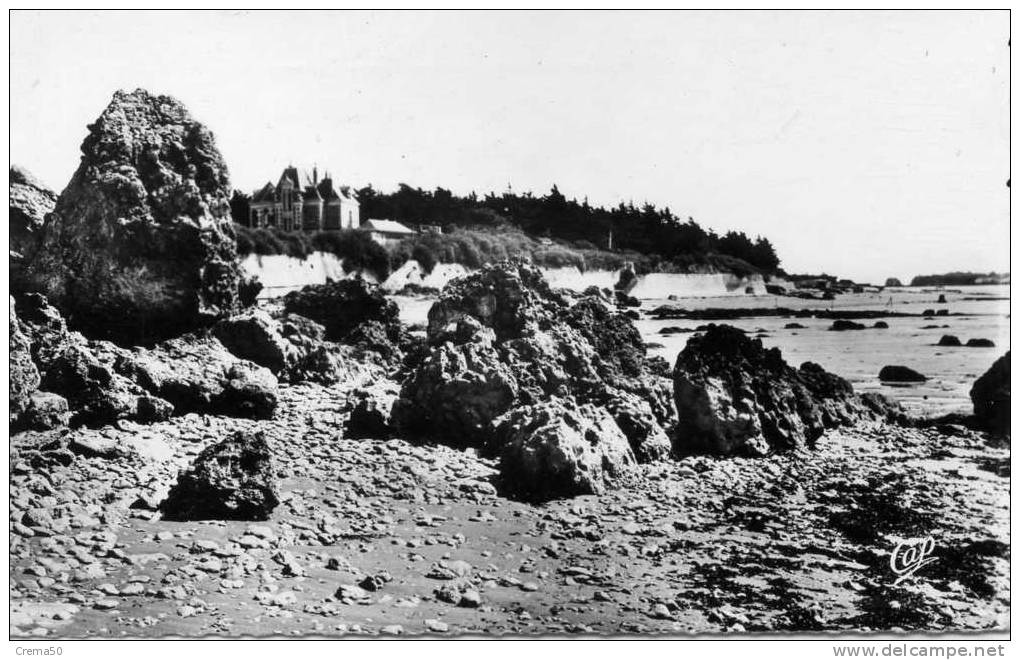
(249, 166), (361, 232)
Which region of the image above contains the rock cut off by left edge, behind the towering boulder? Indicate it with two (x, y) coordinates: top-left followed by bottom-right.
(8, 165), (57, 291)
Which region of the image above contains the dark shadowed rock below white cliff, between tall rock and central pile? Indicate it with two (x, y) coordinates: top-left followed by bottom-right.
(284, 278), (400, 342)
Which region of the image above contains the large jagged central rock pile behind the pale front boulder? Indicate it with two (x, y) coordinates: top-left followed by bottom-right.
(394, 262), (675, 458)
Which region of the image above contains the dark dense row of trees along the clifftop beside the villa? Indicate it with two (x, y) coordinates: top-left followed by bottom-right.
(231, 184), (779, 272)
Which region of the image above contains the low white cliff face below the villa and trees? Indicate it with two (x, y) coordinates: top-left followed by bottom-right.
(241, 257), (765, 300)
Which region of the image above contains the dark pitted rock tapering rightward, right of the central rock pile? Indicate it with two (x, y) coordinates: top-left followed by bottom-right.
(673, 324), (895, 455)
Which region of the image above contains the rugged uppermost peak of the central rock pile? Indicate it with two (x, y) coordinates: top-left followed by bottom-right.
(426, 261), (566, 344)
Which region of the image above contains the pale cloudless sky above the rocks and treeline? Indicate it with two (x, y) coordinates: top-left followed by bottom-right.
(10, 10), (1010, 284)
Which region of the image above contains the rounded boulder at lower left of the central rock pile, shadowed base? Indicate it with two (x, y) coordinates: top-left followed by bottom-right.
(393, 343), (519, 447)
